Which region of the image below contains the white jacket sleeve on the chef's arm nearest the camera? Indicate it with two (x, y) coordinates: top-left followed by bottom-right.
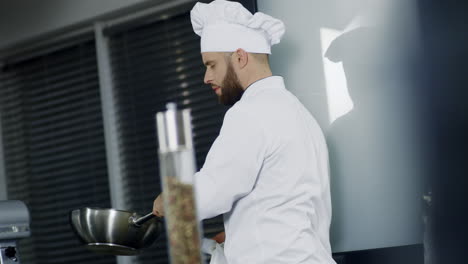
(195, 107), (266, 220)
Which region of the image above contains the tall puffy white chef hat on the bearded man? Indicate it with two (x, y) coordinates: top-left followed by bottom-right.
(190, 0), (285, 54)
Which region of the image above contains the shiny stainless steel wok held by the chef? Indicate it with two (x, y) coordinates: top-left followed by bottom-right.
(70, 207), (163, 255)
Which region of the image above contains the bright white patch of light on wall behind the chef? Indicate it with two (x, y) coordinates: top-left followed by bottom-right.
(320, 28), (353, 124)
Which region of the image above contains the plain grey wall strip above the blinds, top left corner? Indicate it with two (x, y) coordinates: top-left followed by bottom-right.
(0, 0), (145, 49)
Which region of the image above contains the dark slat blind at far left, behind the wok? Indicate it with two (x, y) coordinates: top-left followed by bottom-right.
(0, 38), (115, 264)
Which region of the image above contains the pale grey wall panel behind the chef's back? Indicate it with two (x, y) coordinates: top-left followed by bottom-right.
(258, 0), (422, 252)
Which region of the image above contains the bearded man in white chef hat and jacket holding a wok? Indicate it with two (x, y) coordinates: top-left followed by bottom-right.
(153, 0), (335, 264)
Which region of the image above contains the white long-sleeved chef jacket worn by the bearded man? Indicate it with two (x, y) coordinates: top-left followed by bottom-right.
(195, 76), (335, 264)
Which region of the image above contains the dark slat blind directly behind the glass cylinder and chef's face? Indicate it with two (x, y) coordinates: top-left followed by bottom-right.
(108, 10), (227, 264)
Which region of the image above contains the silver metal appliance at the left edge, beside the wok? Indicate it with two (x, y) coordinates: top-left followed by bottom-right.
(0, 200), (31, 264)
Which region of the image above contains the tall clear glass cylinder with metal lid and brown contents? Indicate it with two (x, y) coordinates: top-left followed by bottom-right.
(156, 103), (203, 264)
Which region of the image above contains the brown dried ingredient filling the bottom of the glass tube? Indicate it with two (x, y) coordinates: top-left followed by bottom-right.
(164, 177), (201, 264)
